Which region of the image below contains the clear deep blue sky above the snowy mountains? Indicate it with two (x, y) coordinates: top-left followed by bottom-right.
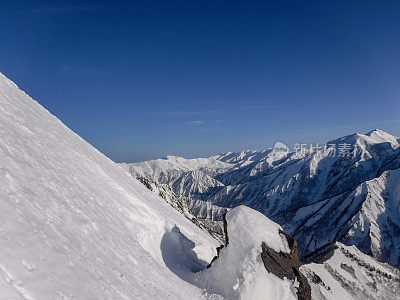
(0, 1), (400, 161)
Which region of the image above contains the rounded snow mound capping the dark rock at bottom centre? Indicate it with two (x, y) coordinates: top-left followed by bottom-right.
(197, 206), (297, 299)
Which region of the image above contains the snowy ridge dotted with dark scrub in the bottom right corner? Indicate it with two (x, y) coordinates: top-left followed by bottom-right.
(300, 243), (400, 300)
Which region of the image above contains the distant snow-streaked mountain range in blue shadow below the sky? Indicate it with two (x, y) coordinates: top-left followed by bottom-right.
(129, 130), (400, 265)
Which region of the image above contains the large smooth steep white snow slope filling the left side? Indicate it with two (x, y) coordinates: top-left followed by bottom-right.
(0, 75), (222, 299)
